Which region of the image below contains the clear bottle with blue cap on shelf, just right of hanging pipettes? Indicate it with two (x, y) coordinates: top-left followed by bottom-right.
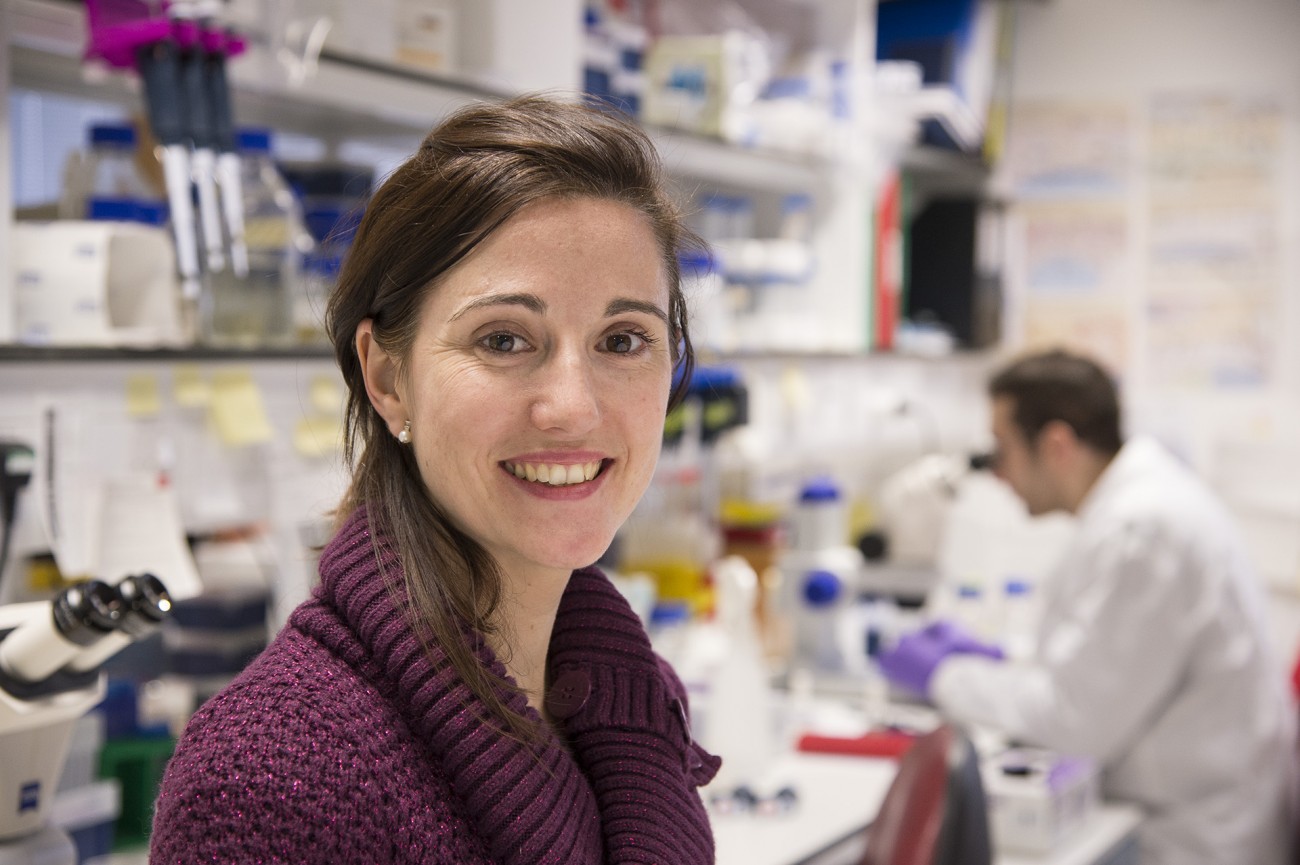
(202, 129), (312, 347)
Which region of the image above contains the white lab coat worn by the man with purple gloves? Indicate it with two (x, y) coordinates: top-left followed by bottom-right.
(931, 438), (1296, 865)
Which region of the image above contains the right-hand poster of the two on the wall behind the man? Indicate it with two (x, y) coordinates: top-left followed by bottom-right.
(1144, 94), (1283, 390)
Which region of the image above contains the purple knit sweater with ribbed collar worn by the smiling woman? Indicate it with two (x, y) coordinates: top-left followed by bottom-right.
(150, 512), (719, 865)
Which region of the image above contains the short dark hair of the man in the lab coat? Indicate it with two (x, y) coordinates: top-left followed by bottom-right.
(988, 350), (1123, 457)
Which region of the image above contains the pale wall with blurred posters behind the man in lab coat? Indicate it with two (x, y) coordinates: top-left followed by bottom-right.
(995, 0), (1300, 661)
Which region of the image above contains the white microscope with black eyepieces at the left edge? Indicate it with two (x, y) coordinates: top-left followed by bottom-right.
(0, 441), (172, 865)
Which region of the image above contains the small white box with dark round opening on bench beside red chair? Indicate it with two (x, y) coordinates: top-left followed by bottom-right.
(982, 748), (1100, 855)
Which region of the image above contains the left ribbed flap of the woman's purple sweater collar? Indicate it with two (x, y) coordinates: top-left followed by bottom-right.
(309, 509), (602, 865)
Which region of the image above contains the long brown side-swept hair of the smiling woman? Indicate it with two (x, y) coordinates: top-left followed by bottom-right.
(326, 96), (699, 740)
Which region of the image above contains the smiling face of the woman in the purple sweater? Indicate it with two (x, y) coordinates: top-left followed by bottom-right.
(397, 198), (672, 576)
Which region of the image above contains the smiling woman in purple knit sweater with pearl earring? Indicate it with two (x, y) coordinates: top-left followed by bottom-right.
(151, 98), (718, 864)
